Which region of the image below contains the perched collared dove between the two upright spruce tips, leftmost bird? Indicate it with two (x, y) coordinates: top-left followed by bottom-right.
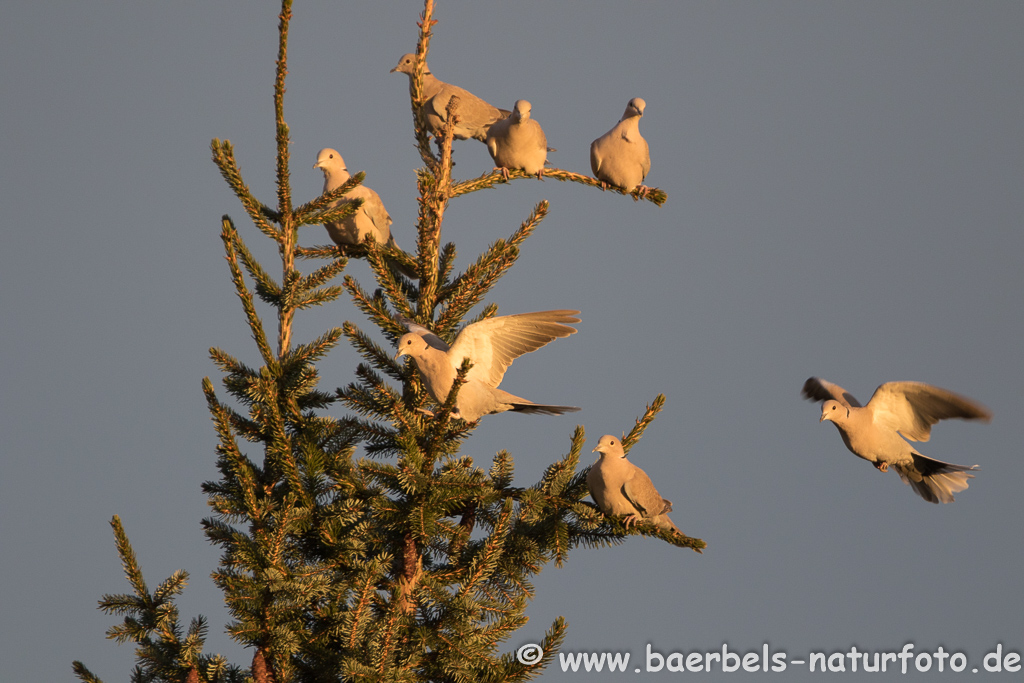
(313, 147), (417, 278)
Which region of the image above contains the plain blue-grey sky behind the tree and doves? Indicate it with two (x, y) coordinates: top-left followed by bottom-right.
(0, 0), (1024, 683)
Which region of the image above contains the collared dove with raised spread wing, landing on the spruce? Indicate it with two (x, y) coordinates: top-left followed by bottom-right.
(394, 310), (580, 422)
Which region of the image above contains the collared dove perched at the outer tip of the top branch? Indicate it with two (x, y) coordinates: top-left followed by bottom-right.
(590, 97), (650, 195)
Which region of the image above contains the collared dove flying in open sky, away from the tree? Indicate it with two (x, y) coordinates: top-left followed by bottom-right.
(803, 377), (992, 503)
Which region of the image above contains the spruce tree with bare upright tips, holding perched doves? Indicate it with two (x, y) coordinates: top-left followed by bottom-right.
(74, 0), (705, 683)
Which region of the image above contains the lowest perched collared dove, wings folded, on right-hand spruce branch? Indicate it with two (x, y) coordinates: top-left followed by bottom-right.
(587, 434), (681, 533)
